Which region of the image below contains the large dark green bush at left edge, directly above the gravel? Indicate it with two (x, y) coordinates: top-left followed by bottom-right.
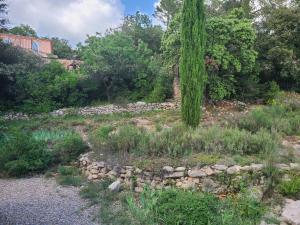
(0, 131), (52, 176)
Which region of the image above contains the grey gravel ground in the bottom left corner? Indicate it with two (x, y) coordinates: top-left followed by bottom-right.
(0, 177), (98, 225)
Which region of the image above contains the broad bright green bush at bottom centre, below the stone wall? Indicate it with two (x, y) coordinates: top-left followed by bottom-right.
(128, 189), (264, 225)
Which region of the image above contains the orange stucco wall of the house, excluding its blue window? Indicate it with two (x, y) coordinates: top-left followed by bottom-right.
(0, 34), (52, 54)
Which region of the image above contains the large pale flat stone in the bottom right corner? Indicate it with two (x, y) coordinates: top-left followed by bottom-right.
(281, 199), (300, 225)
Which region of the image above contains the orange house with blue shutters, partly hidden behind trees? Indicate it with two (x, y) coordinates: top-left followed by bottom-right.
(0, 33), (53, 58)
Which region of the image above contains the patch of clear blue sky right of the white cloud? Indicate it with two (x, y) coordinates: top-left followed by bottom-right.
(122, 0), (156, 15)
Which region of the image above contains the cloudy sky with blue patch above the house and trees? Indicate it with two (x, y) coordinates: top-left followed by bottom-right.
(7, 0), (159, 46)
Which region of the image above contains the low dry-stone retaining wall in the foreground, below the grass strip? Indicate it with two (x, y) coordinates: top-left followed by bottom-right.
(79, 153), (300, 192)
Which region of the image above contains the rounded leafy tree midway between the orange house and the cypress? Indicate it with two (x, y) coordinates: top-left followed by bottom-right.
(79, 31), (157, 101)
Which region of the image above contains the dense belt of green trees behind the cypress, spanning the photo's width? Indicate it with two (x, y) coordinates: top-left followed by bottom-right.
(0, 0), (300, 111)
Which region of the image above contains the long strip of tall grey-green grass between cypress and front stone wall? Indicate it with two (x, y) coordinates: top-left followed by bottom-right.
(93, 125), (278, 157)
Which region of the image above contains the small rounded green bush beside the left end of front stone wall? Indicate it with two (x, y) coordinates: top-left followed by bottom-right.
(53, 133), (88, 164)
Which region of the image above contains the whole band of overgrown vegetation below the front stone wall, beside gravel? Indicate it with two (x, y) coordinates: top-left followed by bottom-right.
(80, 181), (265, 225)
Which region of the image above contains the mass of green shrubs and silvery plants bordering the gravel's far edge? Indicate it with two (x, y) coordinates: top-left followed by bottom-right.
(0, 126), (87, 177)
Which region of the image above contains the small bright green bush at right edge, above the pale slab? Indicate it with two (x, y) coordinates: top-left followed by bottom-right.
(278, 176), (300, 198)
